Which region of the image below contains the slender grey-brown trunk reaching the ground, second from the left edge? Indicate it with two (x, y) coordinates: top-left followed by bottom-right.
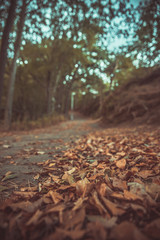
(5, 0), (27, 129)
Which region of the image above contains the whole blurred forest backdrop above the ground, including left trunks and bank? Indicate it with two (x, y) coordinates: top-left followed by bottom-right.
(0, 0), (160, 129)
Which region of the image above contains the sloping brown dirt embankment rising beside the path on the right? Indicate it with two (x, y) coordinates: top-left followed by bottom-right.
(102, 68), (160, 124)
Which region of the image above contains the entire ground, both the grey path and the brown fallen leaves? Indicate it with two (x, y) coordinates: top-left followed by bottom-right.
(0, 114), (160, 240)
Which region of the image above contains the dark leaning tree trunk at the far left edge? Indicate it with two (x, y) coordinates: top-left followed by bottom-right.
(0, 0), (17, 109)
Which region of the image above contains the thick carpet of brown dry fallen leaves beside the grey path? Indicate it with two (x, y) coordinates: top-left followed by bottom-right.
(0, 128), (160, 240)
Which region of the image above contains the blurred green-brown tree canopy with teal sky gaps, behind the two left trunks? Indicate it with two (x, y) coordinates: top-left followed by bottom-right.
(0, 0), (160, 127)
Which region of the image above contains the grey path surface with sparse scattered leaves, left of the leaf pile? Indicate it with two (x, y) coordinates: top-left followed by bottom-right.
(0, 114), (101, 198)
